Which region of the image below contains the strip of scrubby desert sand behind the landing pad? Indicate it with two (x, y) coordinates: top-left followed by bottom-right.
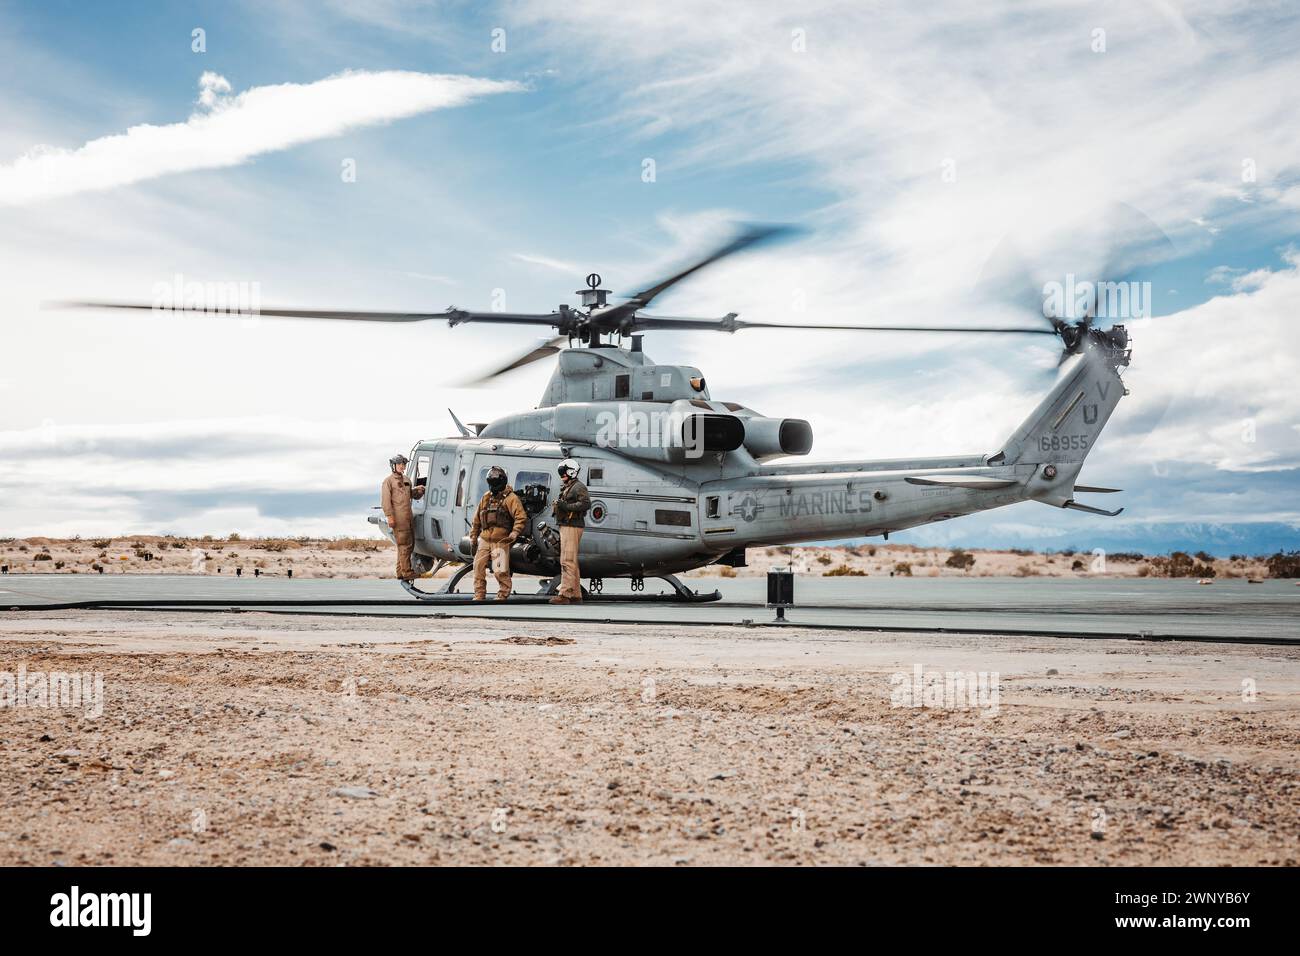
(0, 535), (1269, 579)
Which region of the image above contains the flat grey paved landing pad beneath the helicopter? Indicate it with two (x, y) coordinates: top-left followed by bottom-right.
(0, 575), (1300, 644)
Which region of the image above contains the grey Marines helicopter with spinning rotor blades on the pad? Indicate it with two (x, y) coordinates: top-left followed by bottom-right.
(69, 226), (1131, 600)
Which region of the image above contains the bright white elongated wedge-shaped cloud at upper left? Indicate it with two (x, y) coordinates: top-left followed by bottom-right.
(0, 70), (525, 206)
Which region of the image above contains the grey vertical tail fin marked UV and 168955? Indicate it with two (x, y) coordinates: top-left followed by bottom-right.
(989, 341), (1125, 507)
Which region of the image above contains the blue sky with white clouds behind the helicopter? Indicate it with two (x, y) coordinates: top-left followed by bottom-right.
(0, 0), (1300, 551)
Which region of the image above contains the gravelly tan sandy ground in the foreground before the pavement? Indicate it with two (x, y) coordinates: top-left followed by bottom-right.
(0, 611), (1300, 865)
